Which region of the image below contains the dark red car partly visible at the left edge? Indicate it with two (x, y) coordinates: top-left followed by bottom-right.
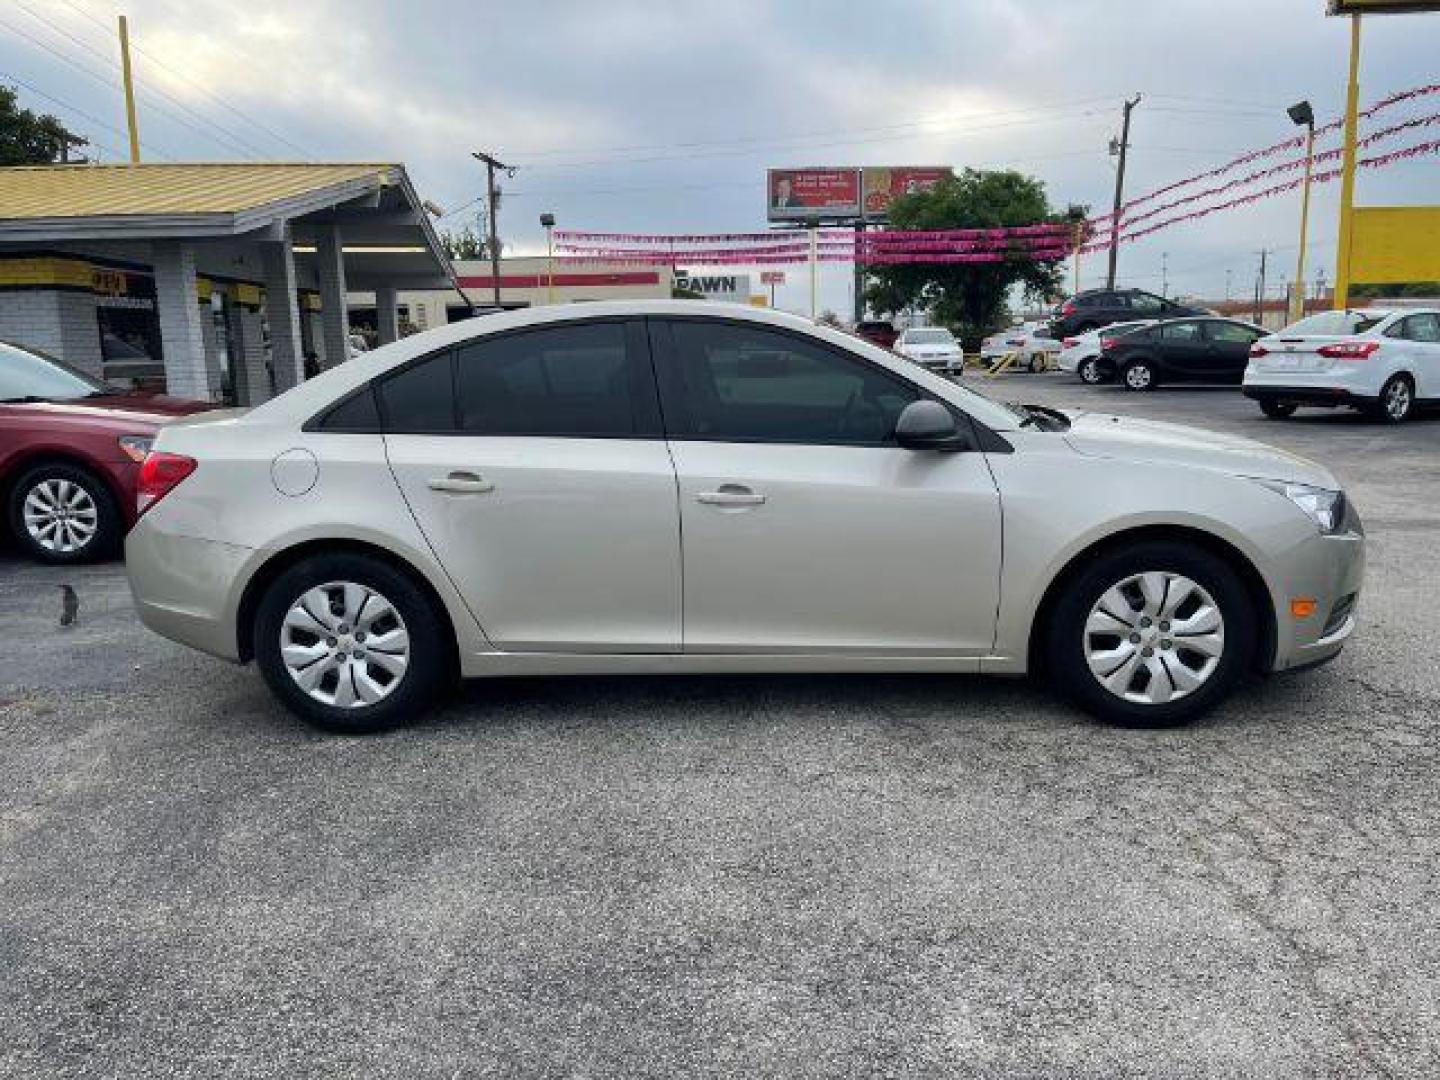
(0, 341), (213, 563)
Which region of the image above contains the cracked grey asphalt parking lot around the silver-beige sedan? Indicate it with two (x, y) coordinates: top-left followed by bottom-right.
(0, 374), (1440, 1079)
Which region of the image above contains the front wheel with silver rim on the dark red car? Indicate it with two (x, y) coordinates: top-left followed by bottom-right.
(10, 462), (125, 563)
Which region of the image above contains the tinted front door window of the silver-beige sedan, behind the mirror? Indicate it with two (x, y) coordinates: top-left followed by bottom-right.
(662, 323), (920, 445)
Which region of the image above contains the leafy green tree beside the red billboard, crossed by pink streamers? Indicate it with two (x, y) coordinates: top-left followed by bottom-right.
(865, 168), (1087, 344)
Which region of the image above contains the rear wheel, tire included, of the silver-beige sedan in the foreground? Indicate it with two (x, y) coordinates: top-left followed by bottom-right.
(255, 554), (451, 734)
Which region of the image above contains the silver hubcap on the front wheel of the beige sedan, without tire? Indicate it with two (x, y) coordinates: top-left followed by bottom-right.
(1084, 570), (1225, 706)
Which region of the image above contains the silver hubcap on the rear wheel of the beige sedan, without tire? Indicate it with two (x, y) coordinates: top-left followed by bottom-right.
(279, 582), (410, 708)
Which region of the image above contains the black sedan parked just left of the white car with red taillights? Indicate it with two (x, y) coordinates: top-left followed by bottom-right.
(1096, 317), (1269, 390)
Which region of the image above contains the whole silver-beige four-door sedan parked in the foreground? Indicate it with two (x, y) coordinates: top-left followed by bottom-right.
(125, 300), (1364, 732)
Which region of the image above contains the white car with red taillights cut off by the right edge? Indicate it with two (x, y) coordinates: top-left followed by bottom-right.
(1243, 308), (1440, 423)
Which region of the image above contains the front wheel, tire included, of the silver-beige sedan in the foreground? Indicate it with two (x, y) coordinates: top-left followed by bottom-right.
(1047, 541), (1257, 727)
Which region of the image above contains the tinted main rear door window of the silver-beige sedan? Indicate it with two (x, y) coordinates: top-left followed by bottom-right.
(456, 323), (638, 436)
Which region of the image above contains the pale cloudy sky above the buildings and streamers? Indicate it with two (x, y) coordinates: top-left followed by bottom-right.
(0, 0), (1440, 311)
